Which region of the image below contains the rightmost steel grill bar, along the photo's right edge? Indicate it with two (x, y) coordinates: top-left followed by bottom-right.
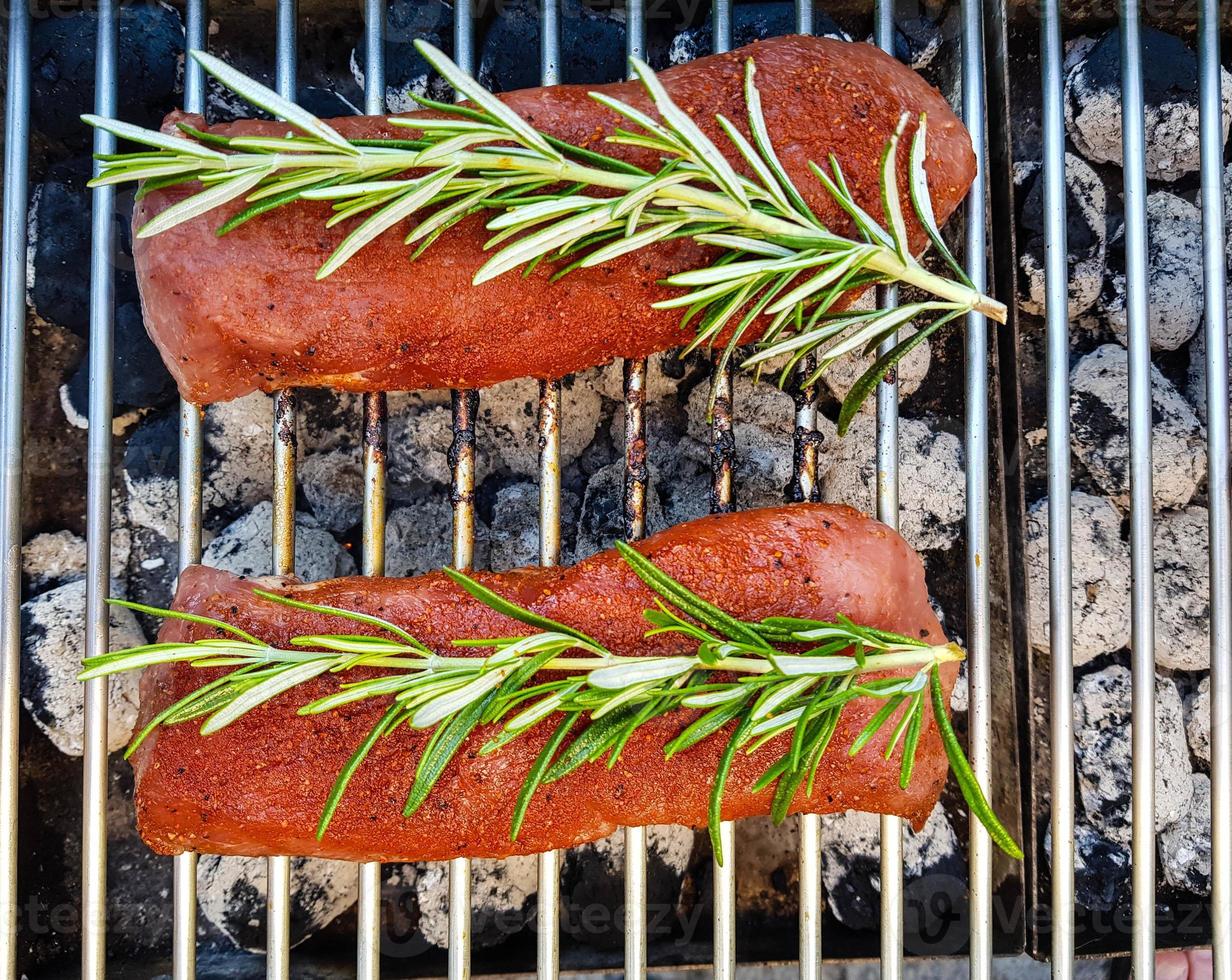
(1198, 0), (1232, 980)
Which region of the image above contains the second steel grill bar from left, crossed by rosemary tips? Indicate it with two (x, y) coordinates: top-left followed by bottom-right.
(81, 0), (120, 980)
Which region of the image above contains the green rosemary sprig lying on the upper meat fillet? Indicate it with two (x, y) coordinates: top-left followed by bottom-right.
(83, 41), (1005, 429)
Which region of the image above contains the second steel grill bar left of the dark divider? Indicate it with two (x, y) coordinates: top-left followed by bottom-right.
(873, 0), (903, 980)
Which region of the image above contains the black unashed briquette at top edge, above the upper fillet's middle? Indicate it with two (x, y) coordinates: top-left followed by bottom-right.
(479, 0), (664, 92)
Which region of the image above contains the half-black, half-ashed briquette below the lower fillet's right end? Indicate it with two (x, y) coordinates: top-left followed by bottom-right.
(822, 802), (966, 936)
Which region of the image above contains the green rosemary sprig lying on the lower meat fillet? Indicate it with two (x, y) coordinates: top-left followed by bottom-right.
(80, 545), (1021, 860)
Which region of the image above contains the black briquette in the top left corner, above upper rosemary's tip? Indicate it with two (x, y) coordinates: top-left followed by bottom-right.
(30, 2), (184, 152)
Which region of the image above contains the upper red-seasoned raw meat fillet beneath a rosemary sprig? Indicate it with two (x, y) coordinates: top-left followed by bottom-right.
(133, 37), (976, 403)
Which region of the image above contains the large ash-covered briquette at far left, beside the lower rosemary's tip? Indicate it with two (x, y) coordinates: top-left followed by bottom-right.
(21, 581), (145, 756)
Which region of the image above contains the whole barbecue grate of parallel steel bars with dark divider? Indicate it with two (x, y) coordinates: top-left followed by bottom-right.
(0, 0), (1232, 980)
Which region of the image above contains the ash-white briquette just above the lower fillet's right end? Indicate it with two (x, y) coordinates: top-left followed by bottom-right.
(822, 415), (966, 551)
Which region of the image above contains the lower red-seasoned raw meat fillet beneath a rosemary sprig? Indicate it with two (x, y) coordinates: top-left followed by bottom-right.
(134, 504), (954, 860)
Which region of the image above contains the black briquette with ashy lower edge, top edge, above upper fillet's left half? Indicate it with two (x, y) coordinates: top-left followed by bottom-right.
(351, 0), (455, 112)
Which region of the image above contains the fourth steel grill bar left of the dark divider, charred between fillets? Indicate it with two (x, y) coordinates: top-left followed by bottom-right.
(710, 0), (736, 980)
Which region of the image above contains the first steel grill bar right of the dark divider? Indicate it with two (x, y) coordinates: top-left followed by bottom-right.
(1040, 0), (1074, 980)
